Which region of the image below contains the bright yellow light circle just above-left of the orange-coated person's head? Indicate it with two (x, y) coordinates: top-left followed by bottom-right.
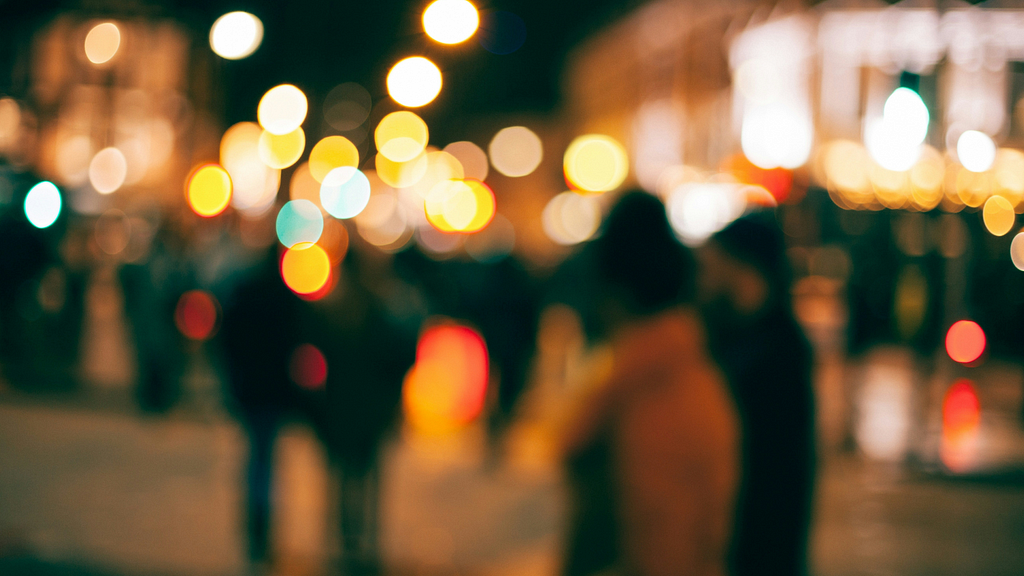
(563, 134), (630, 193)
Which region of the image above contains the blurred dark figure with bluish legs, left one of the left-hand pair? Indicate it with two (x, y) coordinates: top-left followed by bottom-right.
(219, 248), (299, 567)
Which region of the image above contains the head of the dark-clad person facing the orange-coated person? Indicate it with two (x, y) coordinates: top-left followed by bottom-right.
(700, 214), (791, 316)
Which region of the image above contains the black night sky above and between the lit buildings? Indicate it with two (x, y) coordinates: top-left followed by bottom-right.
(0, 0), (641, 136)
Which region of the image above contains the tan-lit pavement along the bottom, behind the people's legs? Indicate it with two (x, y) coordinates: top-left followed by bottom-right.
(0, 398), (1024, 576)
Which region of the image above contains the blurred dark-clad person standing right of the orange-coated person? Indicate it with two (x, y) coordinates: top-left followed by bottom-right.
(700, 214), (815, 576)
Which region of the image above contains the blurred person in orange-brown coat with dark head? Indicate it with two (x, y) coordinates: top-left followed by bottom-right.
(563, 192), (740, 576)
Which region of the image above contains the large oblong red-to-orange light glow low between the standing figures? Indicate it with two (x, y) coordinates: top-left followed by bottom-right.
(402, 324), (489, 434)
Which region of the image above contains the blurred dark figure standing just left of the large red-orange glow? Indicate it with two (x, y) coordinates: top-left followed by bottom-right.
(303, 248), (419, 574)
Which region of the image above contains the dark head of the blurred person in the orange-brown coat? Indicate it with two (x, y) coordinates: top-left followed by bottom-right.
(596, 192), (696, 316)
